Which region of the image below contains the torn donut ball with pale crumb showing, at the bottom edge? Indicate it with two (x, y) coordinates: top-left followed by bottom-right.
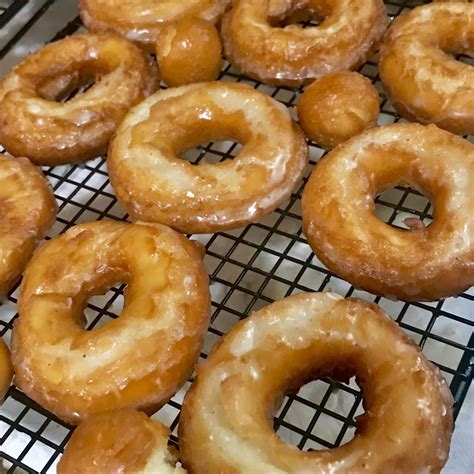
(57, 409), (186, 474)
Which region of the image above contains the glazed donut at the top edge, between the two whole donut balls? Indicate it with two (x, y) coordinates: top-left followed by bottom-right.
(222, 0), (387, 87)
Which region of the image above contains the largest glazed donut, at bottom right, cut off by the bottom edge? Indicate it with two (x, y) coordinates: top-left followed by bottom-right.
(179, 293), (453, 474)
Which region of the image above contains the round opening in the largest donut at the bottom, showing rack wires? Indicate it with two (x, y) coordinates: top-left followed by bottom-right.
(273, 377), (364, 451)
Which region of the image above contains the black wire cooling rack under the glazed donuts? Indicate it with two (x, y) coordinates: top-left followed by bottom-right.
(0, 0), (474, 473)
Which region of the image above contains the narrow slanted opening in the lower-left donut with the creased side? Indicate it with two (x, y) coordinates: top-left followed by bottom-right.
(84, 282), (126, 331)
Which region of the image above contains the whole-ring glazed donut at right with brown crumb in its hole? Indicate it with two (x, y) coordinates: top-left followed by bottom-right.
(302, 124), (474, 301)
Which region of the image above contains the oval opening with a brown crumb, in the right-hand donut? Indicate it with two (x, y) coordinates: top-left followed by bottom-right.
(375, 186), (433, 230)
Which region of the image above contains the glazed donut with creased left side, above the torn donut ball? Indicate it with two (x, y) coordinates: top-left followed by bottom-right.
(12, 221), (210, 423)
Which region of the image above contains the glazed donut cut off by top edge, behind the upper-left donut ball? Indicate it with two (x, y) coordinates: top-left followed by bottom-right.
(79, 0), (230, 53)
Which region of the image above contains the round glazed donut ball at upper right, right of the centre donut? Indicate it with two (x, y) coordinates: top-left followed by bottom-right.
(298, 71), (380, 150)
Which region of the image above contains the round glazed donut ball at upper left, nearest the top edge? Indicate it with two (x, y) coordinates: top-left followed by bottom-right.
(156, 16), (223, 87)
